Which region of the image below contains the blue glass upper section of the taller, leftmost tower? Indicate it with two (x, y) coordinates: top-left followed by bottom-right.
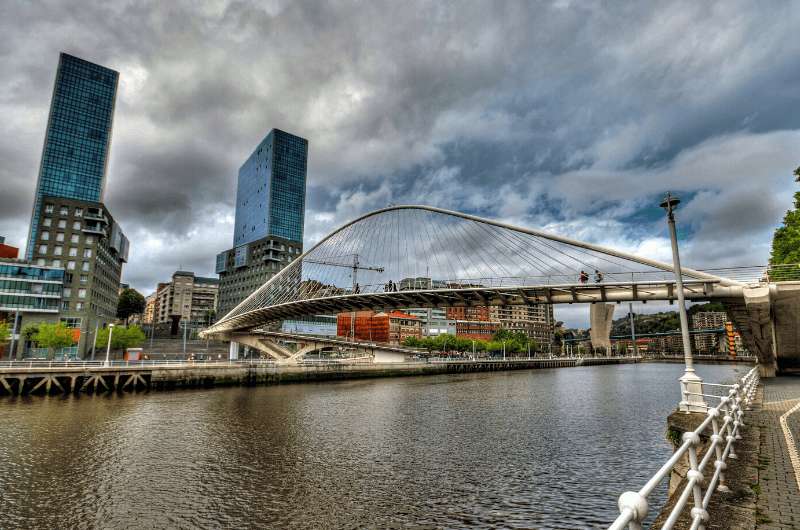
(25, 53), (119, 259)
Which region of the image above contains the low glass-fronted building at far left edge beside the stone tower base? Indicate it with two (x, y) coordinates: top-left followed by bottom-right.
(0, 258), (65, 359)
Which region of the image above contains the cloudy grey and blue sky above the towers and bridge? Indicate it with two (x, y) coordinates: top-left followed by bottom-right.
(0, 0), (800, 322)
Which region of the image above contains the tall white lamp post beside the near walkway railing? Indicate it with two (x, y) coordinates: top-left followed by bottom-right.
(660, 193), (708, 412)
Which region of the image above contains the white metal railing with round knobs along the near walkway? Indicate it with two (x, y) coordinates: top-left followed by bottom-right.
(609, 367), (759, 530)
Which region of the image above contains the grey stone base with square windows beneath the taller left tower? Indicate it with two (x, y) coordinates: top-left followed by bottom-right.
(31, 196), (129, 357)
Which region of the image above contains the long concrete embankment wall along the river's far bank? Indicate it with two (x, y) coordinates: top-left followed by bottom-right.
(0, 357), (641, 396)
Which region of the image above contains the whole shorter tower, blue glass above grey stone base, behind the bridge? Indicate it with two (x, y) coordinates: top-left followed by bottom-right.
(215, 129), (308, 316)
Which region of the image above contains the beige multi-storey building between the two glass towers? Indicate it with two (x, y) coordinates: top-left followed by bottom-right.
(153, 271), (219, 336)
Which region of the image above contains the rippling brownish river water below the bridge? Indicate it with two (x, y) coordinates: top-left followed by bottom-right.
(0, 364), (746, 528)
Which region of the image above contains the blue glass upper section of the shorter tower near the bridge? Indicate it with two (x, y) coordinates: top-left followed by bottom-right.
(233, 129), (308, 247)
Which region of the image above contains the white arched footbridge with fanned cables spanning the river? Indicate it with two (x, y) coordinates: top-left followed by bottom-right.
(202, 205), (800, 377)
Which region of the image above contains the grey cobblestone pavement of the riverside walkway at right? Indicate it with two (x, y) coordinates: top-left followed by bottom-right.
(756, 377), (800, 530)
